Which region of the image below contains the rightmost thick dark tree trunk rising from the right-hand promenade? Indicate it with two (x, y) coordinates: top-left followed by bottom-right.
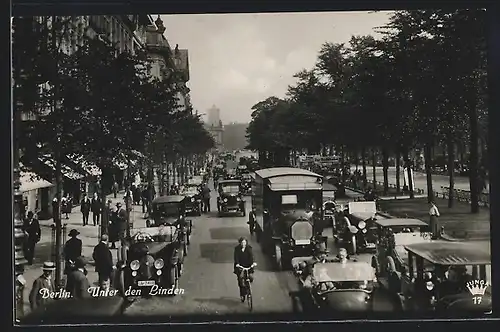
(468, 97), (479, 213)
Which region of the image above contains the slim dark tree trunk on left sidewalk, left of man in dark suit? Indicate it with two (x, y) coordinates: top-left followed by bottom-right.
(52, 151), (63, 288)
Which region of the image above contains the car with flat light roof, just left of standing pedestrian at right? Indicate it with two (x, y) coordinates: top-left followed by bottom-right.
(372, 218), (431, 288)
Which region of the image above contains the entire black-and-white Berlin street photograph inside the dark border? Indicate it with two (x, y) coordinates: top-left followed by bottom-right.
(12, 9), (492, 325)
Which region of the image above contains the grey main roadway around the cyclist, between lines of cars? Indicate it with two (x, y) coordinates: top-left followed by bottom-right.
(125, 183), (394, 319)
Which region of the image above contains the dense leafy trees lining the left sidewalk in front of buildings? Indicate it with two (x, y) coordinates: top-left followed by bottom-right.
(12, 16), (214, 282)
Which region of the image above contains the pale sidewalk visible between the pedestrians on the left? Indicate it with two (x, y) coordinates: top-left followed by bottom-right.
(24, 192), (146, 314)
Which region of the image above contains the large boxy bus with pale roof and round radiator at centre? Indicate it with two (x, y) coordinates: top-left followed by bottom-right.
(252, 167), (323, 270)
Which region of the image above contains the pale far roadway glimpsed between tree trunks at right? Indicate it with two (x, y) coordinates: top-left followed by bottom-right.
(351, 166), (489, 192)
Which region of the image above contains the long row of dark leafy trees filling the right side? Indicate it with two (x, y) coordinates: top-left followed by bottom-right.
(247, 9), (488, 212)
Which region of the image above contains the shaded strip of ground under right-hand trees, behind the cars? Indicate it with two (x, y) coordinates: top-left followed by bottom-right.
(379, 197), (490, 240)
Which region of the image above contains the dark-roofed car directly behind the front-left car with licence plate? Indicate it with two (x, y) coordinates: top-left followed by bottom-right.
(146, 195), (193, 248)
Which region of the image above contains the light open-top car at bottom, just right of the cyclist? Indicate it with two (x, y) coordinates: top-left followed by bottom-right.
(291, 257), (376, 314)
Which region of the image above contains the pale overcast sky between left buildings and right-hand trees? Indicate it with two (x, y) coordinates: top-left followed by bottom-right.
(159, 12), (389, 123)
